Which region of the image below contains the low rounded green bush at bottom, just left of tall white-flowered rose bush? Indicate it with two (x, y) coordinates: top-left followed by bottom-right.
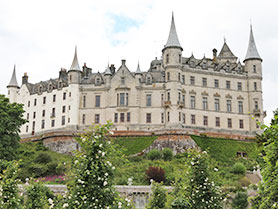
(25, 181), (54, 209)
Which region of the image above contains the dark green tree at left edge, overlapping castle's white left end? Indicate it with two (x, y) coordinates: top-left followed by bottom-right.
(0, 95), (27, 160)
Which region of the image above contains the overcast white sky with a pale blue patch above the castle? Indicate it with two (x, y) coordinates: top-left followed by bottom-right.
(0, 0), (278, 123)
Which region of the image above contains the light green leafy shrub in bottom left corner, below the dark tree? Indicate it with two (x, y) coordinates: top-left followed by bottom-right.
(0, 160), (22, 209)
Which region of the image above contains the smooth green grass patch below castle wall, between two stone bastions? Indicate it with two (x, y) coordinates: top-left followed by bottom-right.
(112, 136), (157, 156)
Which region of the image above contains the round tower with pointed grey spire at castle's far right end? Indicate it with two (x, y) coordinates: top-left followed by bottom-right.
(243, 25), (264, 131)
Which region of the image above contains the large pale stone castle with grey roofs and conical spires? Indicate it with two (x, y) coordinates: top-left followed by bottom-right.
(7, 16), (265, 137)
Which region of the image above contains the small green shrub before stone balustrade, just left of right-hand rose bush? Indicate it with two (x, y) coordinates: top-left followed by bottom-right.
(147, 182), (167, 209)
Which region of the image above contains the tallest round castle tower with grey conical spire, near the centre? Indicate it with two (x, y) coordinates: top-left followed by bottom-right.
(162, 14), (183, 128)
